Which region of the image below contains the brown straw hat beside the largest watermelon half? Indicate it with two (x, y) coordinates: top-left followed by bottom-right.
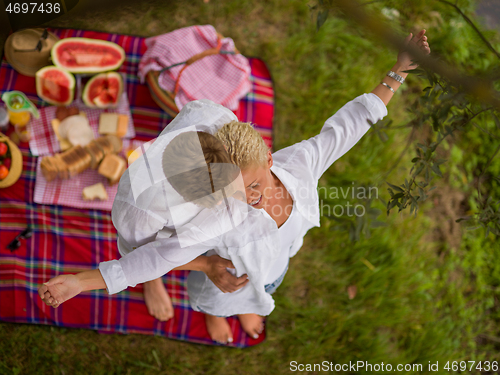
(5, 28), (59, 77)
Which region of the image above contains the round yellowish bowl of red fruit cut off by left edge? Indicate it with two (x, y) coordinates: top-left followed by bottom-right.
(0, 133), (23, 188)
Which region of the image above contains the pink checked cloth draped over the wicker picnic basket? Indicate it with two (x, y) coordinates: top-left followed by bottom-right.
(139, 25), (251, 111)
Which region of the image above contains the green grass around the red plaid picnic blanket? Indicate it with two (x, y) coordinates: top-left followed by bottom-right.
(0, 0), (500, 374)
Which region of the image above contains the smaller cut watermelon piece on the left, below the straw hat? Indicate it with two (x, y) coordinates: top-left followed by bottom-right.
(36, 66), (75, 105)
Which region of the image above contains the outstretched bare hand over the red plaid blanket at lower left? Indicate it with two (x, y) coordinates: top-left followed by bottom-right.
(38, 275), (82, 308)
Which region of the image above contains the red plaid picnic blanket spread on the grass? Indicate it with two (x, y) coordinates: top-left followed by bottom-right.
(0, 29), (274, 347)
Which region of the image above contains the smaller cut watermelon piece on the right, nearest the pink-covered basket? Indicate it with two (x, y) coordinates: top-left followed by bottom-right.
(82, 72), (123, 108)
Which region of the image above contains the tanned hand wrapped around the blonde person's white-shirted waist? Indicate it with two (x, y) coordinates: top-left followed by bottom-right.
(204, 255), (249, 293)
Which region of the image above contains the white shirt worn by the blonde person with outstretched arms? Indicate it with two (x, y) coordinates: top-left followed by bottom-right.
(99, 93), (387, 316)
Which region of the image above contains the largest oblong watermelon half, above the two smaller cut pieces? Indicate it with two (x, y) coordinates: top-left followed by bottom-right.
(51, 38), (125, 73)
